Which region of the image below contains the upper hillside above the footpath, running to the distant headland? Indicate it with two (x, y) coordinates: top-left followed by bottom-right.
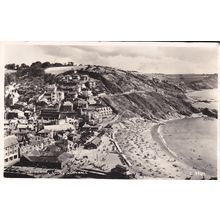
(82, 66), (218, 93)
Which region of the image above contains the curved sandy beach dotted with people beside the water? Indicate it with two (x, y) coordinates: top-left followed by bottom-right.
(113, 118), (215, 179)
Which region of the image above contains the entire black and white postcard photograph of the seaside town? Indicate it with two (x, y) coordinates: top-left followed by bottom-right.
(3, 42), (219, 180)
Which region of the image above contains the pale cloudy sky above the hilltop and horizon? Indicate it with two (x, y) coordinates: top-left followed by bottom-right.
(4, 42), (218, 74)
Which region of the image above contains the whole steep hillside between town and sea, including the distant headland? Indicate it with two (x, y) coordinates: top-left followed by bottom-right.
(80, 66), (218, 119)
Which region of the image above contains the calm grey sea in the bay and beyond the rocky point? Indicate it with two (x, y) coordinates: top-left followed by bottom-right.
(160, 89), (218, 177)
